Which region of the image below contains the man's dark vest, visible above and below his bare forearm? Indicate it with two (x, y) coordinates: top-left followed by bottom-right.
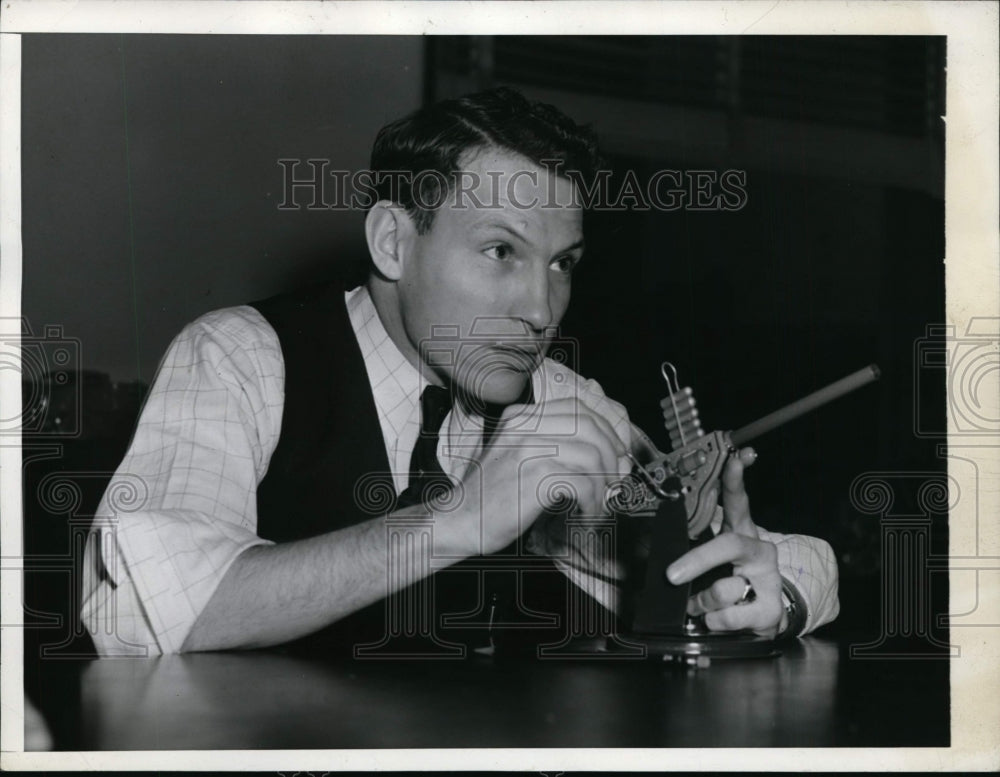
(253, 284), (569, 656)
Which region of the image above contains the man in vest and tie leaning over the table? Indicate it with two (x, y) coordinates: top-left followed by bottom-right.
(83, 89), (838, 654)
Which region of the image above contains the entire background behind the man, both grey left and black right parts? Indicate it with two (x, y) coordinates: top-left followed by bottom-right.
(22, 35), (946, 680)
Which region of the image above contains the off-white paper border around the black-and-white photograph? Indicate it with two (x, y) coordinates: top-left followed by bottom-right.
(0, 0), (1000, 771)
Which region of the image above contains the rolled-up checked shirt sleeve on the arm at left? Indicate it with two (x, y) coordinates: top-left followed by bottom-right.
(82, 306), (284, 655)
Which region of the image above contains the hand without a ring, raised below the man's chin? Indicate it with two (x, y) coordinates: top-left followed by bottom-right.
(449, 397), (631, 555)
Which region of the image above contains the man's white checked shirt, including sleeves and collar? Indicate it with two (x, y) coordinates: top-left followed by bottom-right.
(82, 287), (839, 655)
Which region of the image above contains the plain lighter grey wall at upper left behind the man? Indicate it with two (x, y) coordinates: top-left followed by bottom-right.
(22, 35), (423, 382)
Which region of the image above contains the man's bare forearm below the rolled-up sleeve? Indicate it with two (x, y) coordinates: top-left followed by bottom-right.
(181, 506), (461, 651)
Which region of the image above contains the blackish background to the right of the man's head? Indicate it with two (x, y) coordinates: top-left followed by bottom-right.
(429, 36), (947, 600)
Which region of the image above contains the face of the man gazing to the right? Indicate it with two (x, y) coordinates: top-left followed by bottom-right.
(398, 148), (583, 405)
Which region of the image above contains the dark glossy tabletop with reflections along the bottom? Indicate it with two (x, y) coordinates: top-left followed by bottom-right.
(31, 636), (949, 750)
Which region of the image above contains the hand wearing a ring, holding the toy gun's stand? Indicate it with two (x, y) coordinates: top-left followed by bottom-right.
(667, 448), (786, 638)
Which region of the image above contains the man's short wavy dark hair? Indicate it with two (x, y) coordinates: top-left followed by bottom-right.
(371, 87), (604, 234)
